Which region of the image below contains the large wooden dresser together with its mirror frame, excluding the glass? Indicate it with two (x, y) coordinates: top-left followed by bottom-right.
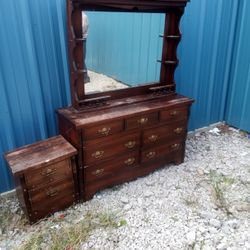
(57, 0), (193, 200)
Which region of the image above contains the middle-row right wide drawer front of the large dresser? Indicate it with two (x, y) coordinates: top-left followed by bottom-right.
(143, 121), (187, 146)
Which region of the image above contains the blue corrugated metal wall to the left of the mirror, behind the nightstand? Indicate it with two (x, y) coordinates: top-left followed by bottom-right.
(0, 0), (69, 192)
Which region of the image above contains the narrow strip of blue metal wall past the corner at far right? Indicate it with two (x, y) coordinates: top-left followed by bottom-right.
(226, 0), (250, 132)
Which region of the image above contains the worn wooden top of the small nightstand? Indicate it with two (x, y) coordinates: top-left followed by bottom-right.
(5, 136), (77, 174)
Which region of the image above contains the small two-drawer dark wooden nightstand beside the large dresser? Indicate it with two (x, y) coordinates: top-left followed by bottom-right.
(5, 136), (79, 222)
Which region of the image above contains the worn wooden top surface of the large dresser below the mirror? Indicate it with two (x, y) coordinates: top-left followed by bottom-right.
(57, 95), (193, 129)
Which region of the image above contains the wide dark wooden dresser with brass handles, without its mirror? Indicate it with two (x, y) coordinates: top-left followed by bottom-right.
(58, 95), (192, 200)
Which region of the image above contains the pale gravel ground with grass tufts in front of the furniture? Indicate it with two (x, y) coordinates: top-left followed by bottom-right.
(0, 125), (250, 250)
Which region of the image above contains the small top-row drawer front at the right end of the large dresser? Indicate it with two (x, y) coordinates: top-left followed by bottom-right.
(160, 107), (189, 122)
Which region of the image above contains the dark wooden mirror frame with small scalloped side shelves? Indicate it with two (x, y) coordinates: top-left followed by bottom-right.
(67, 0), (189, 109)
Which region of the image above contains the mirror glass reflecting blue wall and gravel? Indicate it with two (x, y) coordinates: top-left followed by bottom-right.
(82, 12), (164, 94)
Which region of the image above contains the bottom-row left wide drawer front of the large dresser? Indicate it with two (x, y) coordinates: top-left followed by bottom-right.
(84, 152), (139, 183)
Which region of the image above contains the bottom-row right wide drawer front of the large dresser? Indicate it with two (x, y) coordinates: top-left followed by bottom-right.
(141, 141), (182, 163)
